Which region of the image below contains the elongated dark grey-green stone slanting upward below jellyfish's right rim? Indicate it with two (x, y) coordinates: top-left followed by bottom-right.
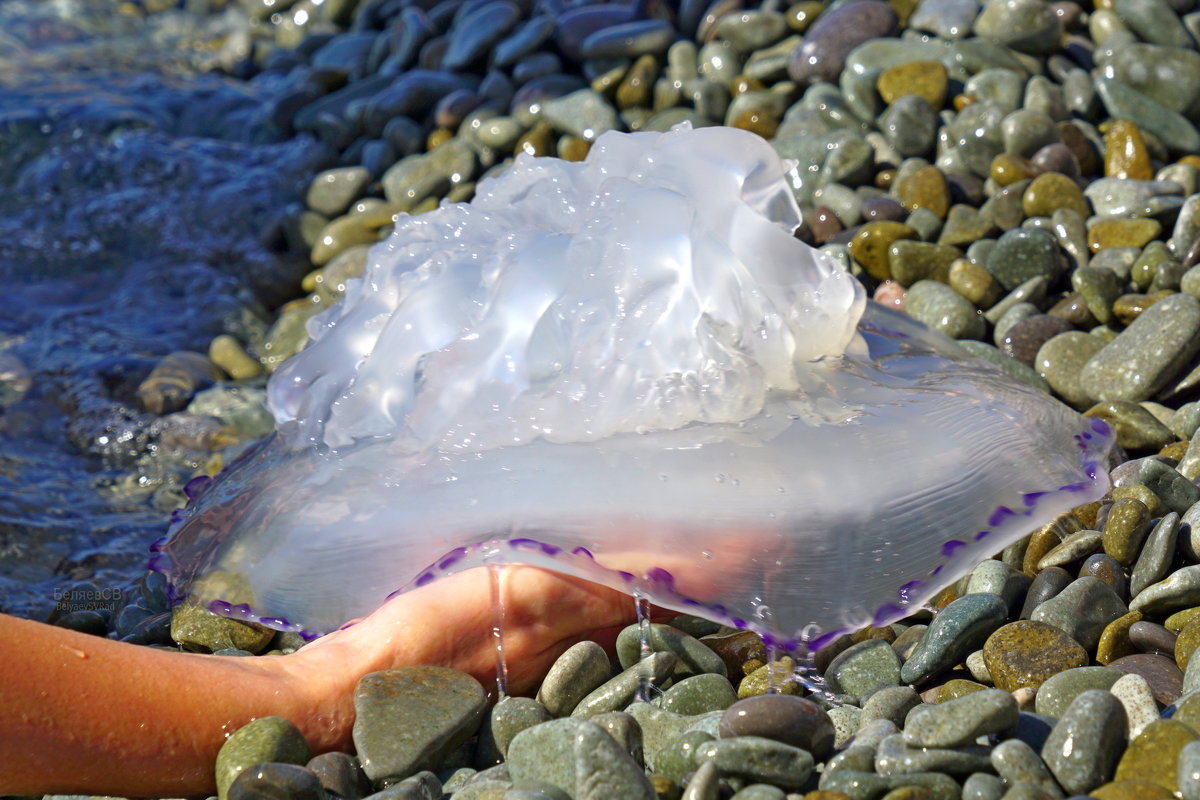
(900, 594), (1008, 684)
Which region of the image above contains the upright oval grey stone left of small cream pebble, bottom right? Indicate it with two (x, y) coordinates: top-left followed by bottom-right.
(1042, 690), (1126, 794)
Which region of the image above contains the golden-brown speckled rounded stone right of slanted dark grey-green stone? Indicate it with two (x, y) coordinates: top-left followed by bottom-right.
(983, 620), (1087, 692)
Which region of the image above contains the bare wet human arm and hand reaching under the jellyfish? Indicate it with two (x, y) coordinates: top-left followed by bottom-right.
(0, 567), (634, 796)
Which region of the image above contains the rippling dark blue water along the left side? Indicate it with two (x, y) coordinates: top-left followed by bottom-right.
(0, 0), (329, 618)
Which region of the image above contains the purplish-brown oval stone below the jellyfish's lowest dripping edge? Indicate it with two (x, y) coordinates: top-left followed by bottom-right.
(719, 694), (834, 760)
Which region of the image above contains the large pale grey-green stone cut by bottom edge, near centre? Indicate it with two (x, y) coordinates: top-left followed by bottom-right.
(505, 717), (655, 800)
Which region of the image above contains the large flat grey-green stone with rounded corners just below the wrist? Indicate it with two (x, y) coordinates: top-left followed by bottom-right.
(353, 667), (487, 781)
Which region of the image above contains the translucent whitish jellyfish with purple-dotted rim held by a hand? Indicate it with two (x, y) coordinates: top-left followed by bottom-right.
(152, 127), (1111, 646)
